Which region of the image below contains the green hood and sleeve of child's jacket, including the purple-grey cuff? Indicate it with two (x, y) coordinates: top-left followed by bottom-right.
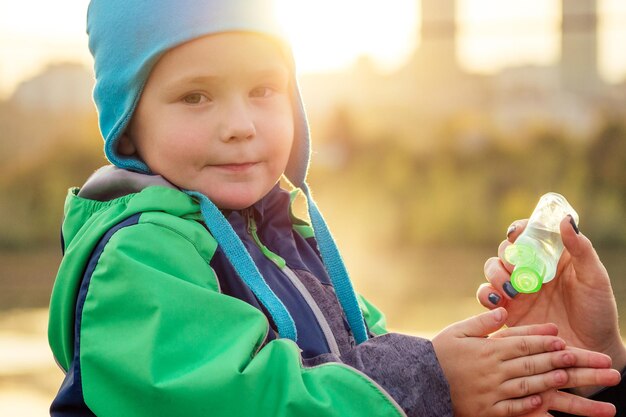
(49, 167), (452, 417)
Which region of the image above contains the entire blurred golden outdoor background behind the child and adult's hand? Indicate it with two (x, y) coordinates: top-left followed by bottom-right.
(0, 0), (626, 416)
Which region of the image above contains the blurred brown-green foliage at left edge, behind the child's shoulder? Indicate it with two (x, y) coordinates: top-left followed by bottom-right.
(0, 109), (106, 249)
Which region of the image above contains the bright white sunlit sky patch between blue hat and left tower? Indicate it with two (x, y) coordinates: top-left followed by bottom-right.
(276, 0), (417, 72)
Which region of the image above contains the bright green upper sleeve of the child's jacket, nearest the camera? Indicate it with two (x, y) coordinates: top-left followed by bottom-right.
(77, 217), (410, 417)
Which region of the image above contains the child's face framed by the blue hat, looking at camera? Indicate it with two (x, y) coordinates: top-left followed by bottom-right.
(119, 33), (294, 210)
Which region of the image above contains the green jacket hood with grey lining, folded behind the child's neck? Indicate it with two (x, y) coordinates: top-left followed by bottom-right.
(48, 166), (202, 366)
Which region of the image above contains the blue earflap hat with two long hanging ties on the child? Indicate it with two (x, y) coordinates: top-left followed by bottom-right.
(87, 0), (367, 342)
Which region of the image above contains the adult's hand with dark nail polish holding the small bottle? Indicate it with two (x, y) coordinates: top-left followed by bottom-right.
(477, 218), (626, 384)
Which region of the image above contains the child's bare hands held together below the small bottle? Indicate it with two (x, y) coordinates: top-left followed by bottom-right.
(433, 308), (619, 417)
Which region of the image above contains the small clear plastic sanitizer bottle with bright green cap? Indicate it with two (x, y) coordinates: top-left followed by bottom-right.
(504, 193), (578, 293)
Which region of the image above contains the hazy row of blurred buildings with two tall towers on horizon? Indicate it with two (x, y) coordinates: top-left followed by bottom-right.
(302, 0), (621, 151)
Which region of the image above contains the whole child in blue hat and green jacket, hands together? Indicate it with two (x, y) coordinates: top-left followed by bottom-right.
(49, 0), (617, 416)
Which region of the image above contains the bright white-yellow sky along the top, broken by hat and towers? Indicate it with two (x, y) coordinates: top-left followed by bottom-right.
(0, 0), (626, 98)
